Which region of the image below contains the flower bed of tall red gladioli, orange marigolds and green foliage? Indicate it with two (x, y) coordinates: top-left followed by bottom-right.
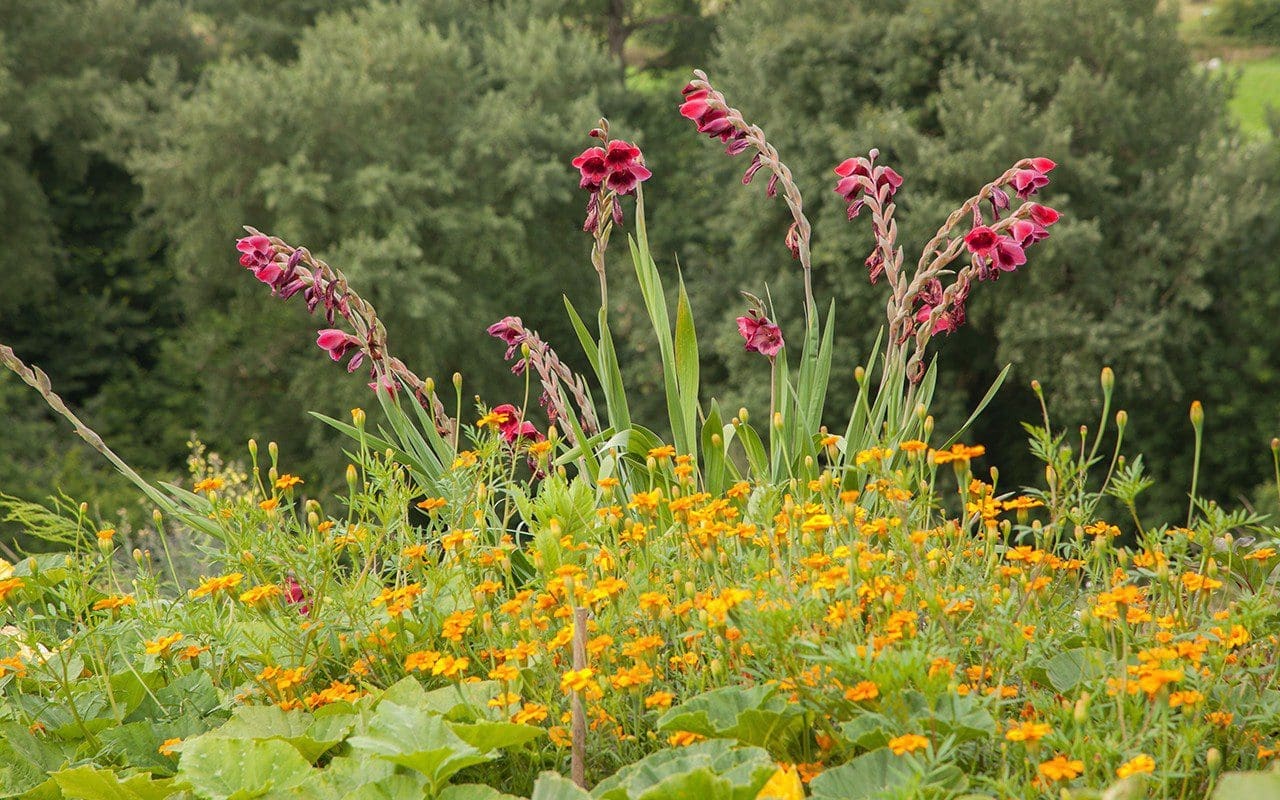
(0, 73), (1280, 800)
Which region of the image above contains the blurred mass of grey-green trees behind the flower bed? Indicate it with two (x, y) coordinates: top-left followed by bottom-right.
(0, 0), (1280, 545)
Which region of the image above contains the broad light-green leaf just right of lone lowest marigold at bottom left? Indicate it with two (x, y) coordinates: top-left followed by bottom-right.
(178, 735), (314, 800)
